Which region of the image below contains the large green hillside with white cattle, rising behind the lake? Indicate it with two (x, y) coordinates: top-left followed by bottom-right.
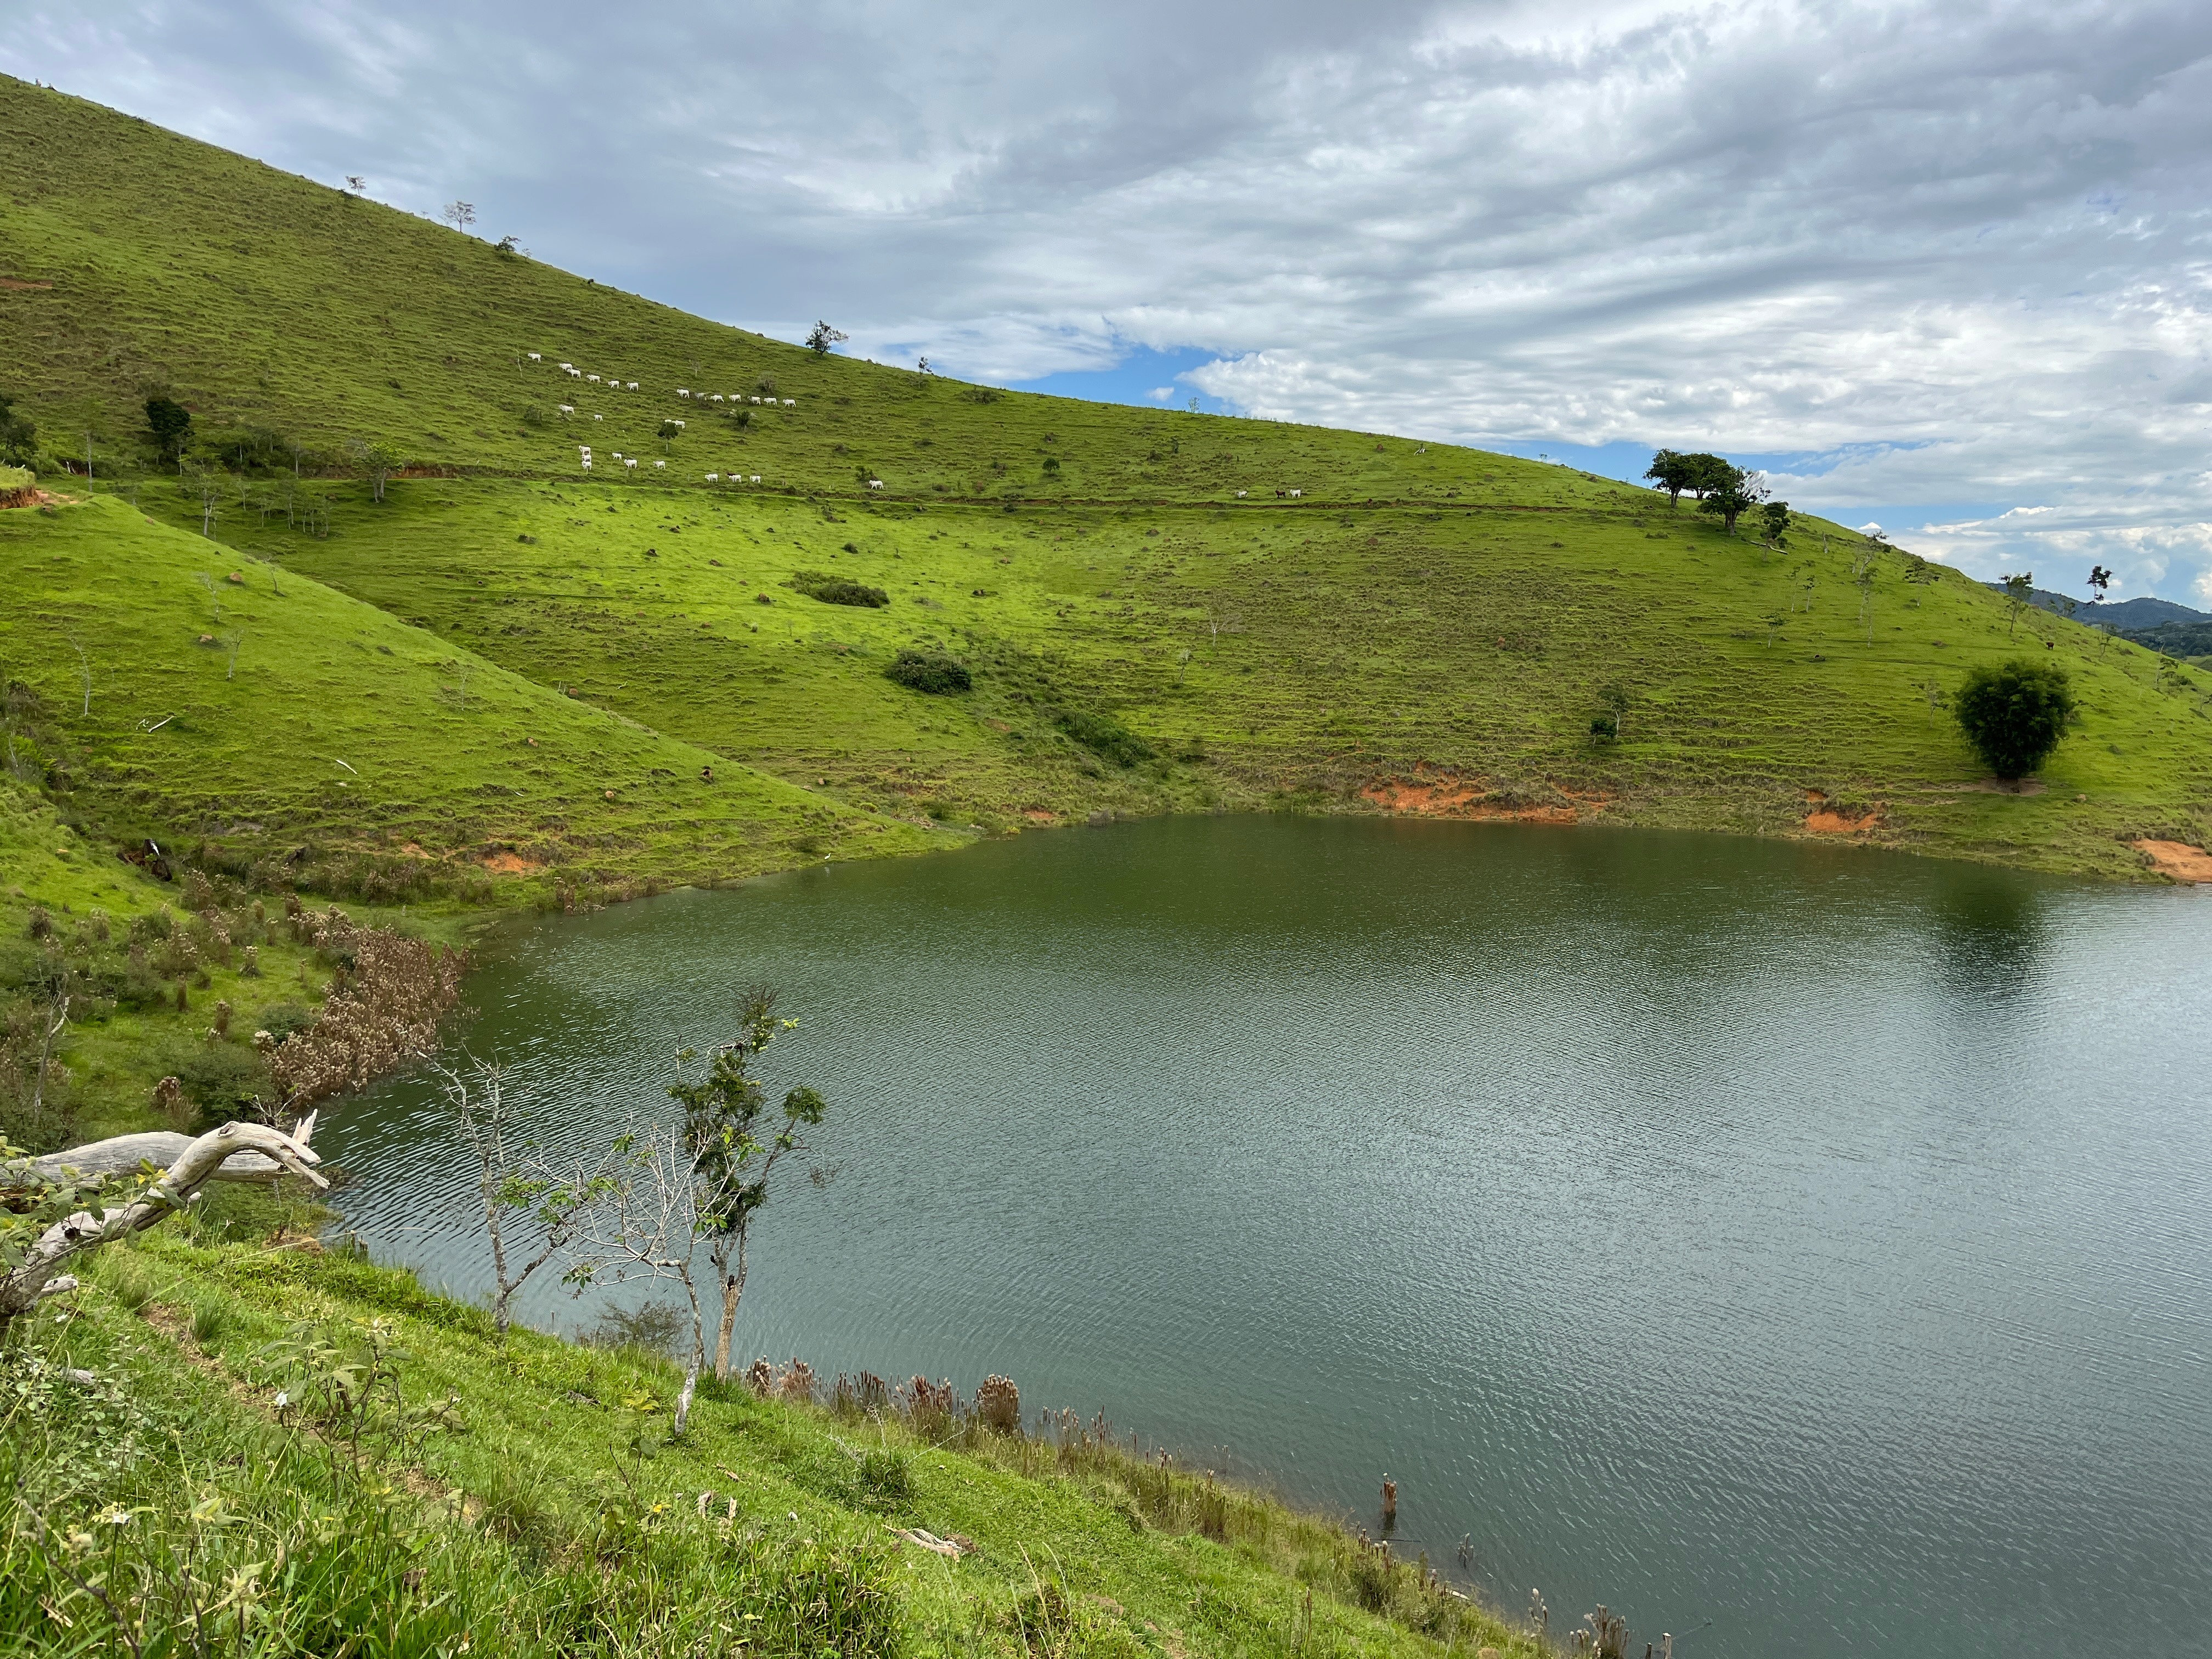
(0, 82), (2212, 898)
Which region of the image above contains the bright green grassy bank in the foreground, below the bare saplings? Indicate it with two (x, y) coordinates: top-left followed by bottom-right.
(0, 1215), (1542, 1659)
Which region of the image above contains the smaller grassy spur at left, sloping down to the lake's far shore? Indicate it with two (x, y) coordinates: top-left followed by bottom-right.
(0, 495), (931, 898)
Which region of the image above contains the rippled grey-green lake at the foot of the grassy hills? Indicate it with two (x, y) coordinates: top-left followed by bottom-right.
(319, 819), (2212, 1659)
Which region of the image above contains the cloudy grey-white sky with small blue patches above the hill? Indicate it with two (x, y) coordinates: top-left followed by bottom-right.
(13, 0), (2212, 611)
